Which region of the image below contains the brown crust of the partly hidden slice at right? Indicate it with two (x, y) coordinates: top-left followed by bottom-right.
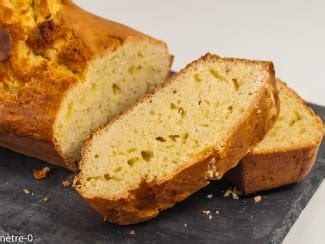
(225, 80), (323, 195)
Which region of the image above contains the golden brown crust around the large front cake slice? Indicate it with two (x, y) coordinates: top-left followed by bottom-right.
(74, 54), (279, 225)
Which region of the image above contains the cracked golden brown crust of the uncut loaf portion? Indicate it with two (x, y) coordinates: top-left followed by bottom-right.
(0, 0), (171, 169)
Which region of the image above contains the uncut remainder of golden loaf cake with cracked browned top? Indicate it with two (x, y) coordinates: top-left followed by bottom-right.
(0, 0), (172, 170)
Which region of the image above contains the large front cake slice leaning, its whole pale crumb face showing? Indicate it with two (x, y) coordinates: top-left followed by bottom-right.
(74, 54), (278, 224)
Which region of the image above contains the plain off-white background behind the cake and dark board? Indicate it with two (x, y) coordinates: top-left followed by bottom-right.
(75, 0), (325, 243)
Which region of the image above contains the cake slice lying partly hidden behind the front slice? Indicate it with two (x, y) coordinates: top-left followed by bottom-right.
(226, 80), (323, 194)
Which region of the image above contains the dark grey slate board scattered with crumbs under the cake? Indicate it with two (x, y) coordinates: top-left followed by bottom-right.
(0, 105), (325, 243)
